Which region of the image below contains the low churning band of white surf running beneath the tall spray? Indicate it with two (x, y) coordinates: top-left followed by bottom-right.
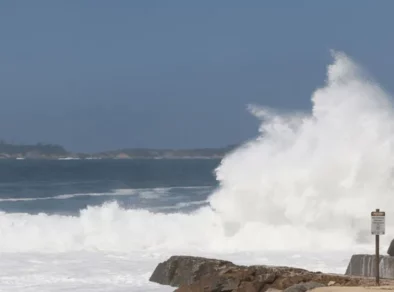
(0, 202), (378, 252)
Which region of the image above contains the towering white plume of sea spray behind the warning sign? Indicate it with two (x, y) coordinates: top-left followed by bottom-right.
(210, 53), (394, 245)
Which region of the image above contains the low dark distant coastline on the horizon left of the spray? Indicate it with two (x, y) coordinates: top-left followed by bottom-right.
(0, 141), (236, 160)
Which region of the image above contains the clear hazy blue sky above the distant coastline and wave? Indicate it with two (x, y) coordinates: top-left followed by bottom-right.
(0, 0), (394, 152)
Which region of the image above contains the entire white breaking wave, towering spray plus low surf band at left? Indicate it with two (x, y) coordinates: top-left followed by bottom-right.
(0, 53), (394, 253)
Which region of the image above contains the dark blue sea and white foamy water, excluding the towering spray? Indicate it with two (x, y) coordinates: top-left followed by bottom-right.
(0, 159), (358, 292)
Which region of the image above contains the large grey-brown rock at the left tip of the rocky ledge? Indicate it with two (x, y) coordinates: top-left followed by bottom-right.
(149, 256), (234, 287)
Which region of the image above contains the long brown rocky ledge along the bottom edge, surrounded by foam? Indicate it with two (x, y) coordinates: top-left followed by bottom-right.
(149, 256), (393, 292)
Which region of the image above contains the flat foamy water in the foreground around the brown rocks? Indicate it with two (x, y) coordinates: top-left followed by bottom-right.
(0, 251), (354, 292)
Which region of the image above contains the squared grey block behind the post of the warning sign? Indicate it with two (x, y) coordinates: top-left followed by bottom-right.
(345, 254), (394, 279)
